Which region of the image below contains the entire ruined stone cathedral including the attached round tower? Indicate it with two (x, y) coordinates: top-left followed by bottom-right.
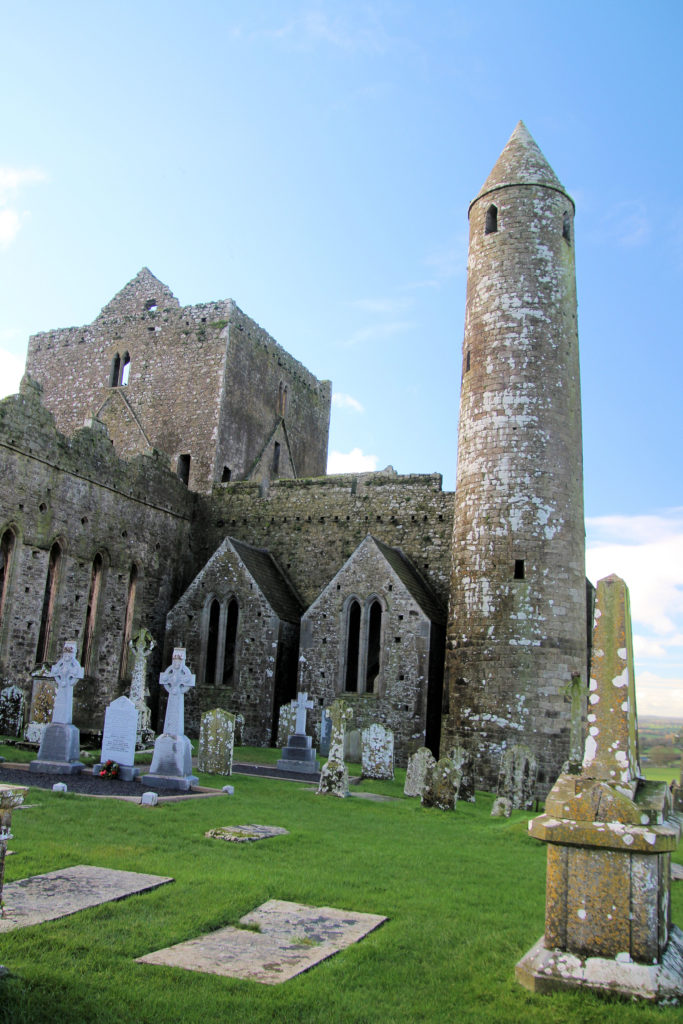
(0, 122), (592, 792)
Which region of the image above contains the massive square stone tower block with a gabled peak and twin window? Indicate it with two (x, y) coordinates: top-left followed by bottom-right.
(27, 269), (331, 492)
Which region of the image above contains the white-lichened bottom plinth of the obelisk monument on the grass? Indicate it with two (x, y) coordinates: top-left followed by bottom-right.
(515, 926), (683, 1004)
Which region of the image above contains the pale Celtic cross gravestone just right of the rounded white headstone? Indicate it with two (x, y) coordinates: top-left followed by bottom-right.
(141, 647), (198, 791)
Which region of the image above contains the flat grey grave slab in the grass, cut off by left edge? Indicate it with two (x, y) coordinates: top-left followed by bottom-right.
(0, 864), (173, 932)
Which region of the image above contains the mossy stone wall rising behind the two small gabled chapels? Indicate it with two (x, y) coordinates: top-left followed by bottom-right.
(197, 473), (454, 605)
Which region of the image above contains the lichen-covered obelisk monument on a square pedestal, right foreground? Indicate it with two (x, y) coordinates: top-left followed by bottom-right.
(516, 575), (683, 1002)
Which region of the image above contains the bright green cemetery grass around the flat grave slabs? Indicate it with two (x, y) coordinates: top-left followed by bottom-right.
(0, 773), (683, 1024)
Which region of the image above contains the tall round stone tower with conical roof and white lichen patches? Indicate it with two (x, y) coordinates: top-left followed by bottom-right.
(440, 121), (587, 792)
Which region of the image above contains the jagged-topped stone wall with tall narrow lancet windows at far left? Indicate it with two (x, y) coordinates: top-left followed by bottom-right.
(0, 382), (196, 729)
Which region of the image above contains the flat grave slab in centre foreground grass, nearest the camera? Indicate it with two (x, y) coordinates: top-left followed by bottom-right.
(137, 899), (386, 985)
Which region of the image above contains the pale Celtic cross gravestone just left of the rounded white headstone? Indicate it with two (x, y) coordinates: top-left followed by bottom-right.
(29, 641), (84, 775)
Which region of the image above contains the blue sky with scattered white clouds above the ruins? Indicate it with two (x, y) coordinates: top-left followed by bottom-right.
(0, 0), (683, 716)
